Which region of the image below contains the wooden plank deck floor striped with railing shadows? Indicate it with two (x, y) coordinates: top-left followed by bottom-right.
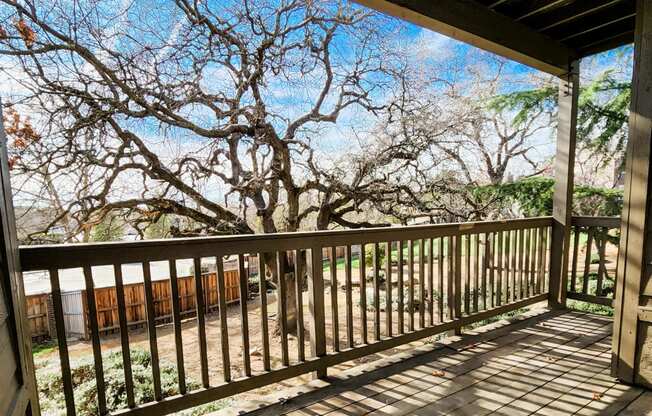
(220, 311), (652, 416)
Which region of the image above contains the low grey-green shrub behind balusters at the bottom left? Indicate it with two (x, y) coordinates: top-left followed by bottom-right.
(37, 349), (225, 416)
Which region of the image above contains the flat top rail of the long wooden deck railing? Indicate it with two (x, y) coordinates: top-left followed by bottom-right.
(20, 217), (552, 271)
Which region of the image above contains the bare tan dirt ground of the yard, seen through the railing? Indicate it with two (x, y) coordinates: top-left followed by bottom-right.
(36, 267), (450, 408)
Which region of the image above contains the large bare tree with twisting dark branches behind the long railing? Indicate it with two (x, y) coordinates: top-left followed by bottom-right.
(0, 0), (416, 334)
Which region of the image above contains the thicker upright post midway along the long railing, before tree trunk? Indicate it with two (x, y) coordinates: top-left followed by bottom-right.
(308, 246), (326, 378)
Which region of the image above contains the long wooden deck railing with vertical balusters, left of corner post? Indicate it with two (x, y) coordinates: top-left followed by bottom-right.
(20, 217), (552, 415)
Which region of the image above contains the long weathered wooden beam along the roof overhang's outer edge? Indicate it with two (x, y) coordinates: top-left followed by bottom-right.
(355, 0), (577, 76)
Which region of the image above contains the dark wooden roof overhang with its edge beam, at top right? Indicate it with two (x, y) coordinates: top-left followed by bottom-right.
(356, 0), (636, 75)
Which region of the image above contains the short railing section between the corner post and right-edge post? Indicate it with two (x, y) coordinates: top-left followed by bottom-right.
(567, 217), (620, 306)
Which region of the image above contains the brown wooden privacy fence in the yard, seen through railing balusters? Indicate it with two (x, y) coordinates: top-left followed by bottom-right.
(26, 270), (246, 339)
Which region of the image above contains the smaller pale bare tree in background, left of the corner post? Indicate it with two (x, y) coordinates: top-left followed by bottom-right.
(366, 53), (553, 223)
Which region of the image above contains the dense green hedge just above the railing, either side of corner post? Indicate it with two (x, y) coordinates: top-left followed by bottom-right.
(472, 176), (623, 217)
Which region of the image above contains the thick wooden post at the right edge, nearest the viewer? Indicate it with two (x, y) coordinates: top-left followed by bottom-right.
(611, 0), (652, 386)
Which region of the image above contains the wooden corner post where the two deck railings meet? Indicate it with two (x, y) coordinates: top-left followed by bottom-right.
(548, 61), (580, 308)
